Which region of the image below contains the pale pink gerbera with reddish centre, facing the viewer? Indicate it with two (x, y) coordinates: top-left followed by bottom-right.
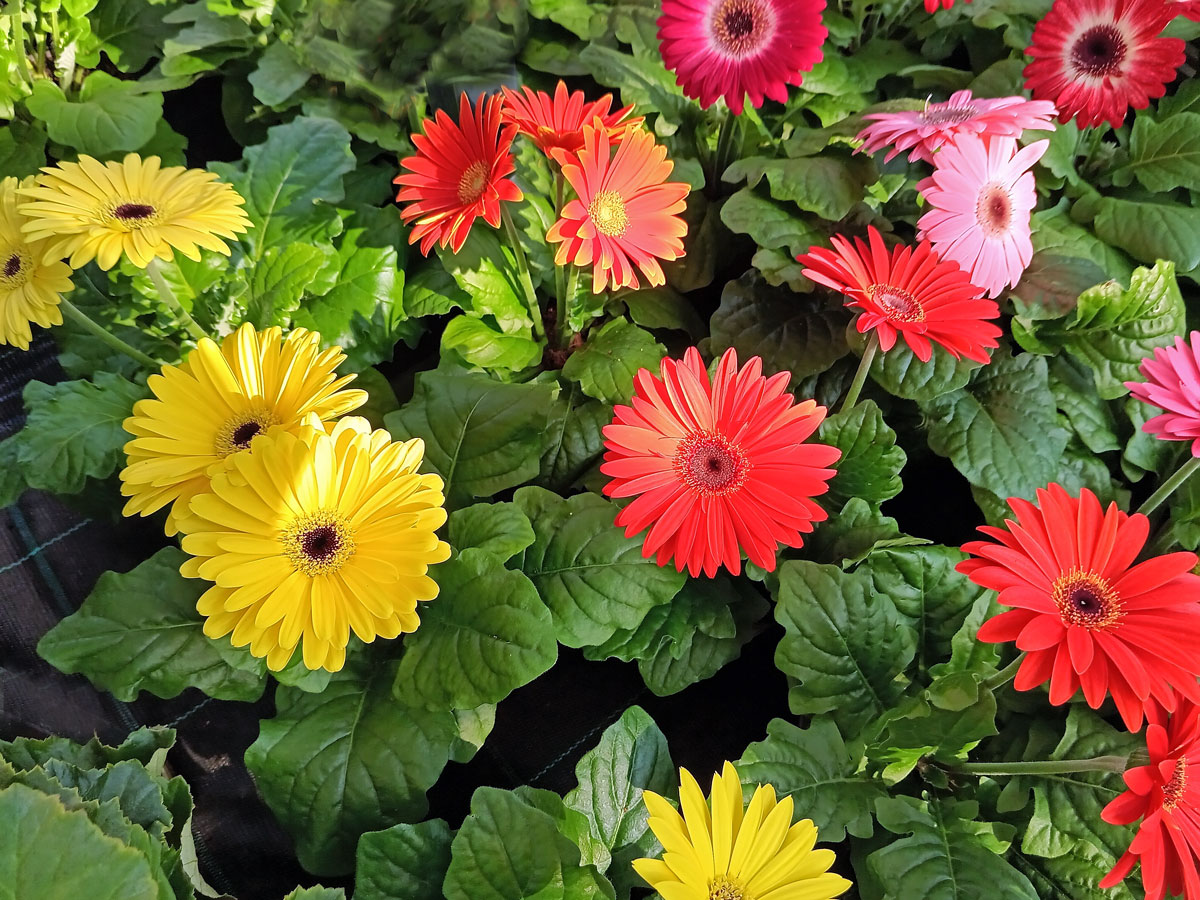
(917, 134), (1050, 296)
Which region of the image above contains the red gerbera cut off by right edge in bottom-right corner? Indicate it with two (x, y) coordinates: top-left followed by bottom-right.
(1099, 700), (1200, 900)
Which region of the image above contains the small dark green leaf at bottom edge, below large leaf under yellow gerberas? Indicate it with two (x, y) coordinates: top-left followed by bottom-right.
(354, 818), (450, 900)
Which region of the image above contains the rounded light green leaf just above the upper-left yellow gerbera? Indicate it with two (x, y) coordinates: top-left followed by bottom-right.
(25, 71), (162, 156)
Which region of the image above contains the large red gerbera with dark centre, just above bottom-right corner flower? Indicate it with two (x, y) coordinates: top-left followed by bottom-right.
(958, 485), (1200, 731)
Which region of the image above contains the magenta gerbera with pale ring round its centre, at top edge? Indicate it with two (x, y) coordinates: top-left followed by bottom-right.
(659, 0), (829, 115)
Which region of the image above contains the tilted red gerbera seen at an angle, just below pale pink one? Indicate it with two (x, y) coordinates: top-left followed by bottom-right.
(797, 226), (1000, 362)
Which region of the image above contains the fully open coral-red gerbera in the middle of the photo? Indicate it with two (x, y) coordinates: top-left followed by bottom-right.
(600, 348), (841, 577)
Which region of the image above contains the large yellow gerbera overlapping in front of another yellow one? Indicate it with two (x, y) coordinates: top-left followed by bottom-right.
(180, 416), (450, 672)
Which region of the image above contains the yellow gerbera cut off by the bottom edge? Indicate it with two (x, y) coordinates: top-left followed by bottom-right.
(634, 762), (850, 900)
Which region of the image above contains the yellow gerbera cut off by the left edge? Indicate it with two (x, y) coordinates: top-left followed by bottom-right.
(0, 178), (74, 350)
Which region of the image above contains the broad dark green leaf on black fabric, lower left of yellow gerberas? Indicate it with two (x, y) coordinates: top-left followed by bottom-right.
(37, 547), (265, 702)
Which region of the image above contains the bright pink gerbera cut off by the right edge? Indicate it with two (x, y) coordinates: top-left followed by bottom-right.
(1124, 331), (1200, 456)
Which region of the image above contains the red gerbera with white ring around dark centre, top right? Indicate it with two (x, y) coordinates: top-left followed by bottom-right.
(1025, 0), (1183, 128)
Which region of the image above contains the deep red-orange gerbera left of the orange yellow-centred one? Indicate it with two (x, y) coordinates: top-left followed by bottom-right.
(395, 94), (522, 256)
